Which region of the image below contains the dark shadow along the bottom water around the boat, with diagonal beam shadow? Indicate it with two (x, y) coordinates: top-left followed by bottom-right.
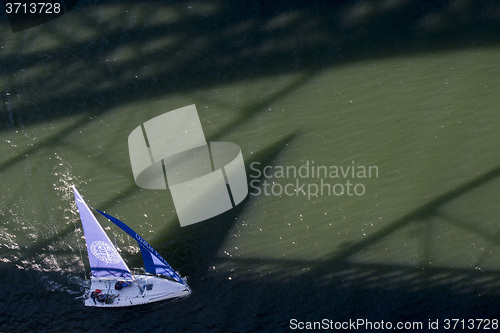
(0, 147), (500, 332)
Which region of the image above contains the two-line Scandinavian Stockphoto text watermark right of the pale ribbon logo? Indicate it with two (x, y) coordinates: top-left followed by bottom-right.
(249, 160), (379, 200)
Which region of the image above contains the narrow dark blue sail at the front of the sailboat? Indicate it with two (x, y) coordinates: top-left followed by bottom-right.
(94, 208), (184, 284)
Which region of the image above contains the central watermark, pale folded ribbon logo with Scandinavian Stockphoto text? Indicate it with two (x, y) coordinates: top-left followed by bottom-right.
(128, 105), (379, 223)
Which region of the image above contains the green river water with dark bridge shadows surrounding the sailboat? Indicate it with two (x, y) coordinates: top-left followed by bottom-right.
(0, 0), (500, 332)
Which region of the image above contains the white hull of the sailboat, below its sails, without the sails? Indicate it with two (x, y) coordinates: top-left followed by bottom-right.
(84, 275), (191, 308)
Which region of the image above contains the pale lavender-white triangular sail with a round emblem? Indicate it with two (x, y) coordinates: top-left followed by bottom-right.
(73, 186), (133, 280)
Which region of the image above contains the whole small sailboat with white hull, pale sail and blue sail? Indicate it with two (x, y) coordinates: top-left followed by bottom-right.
(72, 186), (191, 307)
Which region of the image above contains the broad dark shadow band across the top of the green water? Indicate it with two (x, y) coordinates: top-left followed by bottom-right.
(0, 0), (500, 131)
